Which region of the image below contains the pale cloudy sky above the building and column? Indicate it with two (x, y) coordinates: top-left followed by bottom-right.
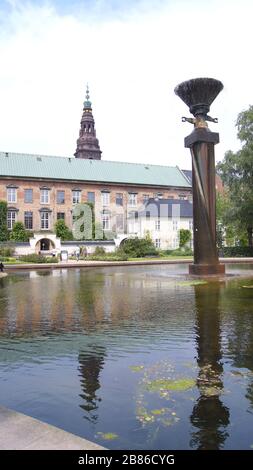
(0, 0), (253, 171)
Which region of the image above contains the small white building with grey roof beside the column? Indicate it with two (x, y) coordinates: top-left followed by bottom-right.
(128, 198), (193, 249)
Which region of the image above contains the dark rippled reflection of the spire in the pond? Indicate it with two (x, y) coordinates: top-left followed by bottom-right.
(78, 345), (105, 423)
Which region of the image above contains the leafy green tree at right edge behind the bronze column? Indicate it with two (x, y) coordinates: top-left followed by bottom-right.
(217, 106), (253, 246)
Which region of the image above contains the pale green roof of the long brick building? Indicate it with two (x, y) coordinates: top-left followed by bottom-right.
(0, 152), (191, 188)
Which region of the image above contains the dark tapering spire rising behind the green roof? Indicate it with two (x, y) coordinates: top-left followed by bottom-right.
(74, 85), (102, 160)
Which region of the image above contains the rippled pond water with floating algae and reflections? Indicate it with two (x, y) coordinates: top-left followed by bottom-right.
(0, 265), (253, 449)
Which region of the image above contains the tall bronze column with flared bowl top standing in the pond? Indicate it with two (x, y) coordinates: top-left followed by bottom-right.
(175, 78), (225, 275)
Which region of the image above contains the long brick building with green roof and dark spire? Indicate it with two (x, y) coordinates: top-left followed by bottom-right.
(0, 86), (191, 244)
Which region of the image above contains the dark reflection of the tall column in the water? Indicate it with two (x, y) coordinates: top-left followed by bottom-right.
(191, 283), (229, 449)
